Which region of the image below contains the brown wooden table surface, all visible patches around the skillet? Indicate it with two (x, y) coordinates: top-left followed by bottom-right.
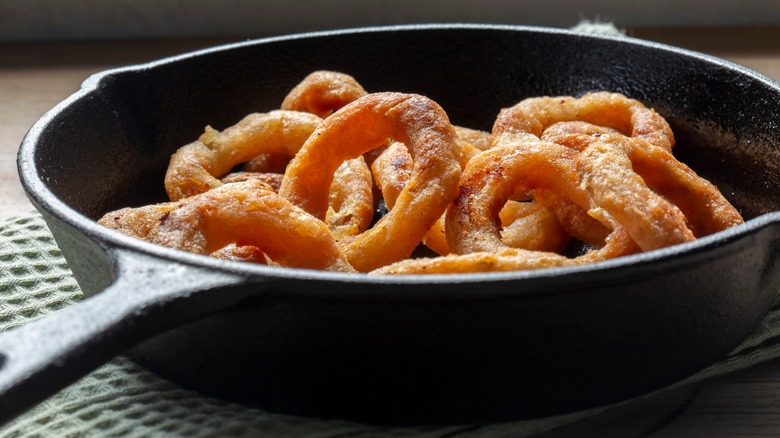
(0, 27), (780, 437)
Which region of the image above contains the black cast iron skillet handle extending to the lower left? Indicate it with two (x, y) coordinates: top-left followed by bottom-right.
(0, 249), (250, 425)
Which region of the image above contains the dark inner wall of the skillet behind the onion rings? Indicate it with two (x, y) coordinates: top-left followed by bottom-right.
(36, 25), (780, 218)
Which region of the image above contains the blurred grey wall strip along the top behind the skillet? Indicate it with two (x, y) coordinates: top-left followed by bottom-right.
(0, 0), (780, 42)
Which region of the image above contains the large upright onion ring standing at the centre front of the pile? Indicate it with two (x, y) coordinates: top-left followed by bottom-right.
(279, 93), (461, 272)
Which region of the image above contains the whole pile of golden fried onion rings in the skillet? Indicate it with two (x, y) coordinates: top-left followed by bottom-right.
(98, 71), (743, 275)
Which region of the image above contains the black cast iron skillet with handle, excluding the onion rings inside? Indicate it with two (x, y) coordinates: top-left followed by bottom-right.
(0, 25), (780, 424)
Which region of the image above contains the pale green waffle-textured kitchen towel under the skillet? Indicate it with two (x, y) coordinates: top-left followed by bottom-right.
(0, 213), (780, 438)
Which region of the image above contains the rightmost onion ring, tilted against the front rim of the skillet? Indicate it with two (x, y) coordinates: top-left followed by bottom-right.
(576, 134), (743, 251)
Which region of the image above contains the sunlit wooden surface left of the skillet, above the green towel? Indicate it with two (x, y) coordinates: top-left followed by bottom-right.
(0, 40), (232, 220)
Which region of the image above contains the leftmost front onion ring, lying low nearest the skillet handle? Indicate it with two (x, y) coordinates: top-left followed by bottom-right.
(98, 180), (354, 272)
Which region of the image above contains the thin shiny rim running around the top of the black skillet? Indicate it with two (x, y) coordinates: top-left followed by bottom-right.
(17, 23), (780, 290)
